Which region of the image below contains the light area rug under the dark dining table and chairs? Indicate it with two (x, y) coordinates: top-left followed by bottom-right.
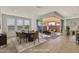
(13, 39), (47, 52)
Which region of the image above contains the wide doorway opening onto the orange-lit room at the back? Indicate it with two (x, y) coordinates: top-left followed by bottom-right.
(37, 17), (64, 32)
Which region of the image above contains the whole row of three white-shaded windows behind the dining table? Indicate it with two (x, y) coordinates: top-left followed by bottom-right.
(3, 15), (31, 31)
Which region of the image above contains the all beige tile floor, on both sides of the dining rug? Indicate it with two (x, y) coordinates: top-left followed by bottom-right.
(0, 35), (79, 53)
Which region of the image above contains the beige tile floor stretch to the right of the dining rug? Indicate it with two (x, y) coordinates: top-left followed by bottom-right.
(24, 36), (79, 53)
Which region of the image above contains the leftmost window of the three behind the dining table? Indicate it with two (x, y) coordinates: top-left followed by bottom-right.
(7, 17), (15, 31)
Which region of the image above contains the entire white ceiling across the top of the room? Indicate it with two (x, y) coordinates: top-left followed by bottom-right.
(0, 6), (79, 17)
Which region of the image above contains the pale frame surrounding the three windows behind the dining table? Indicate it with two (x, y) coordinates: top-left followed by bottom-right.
(2, 14), (31, 32)
